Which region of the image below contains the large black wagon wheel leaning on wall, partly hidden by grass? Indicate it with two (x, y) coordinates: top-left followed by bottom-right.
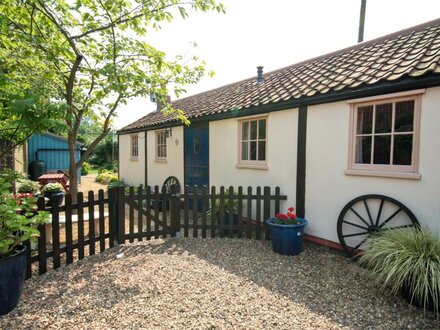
(337, 194), (419, 256)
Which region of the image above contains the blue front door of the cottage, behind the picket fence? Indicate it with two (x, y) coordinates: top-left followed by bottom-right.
(185, 123), (209, 191)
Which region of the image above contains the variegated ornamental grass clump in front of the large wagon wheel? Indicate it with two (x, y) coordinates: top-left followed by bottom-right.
(359, 229), (440, 317)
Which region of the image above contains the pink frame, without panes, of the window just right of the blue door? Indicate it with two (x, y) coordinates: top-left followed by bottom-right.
(236, 115), (269, 170)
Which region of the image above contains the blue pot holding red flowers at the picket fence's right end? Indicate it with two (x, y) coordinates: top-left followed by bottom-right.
(266, 218), (308, 256)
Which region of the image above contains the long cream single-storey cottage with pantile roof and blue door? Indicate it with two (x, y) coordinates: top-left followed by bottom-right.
(119, 19), (440, 251)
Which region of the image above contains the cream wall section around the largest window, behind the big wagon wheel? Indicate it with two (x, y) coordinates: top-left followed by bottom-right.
(305, 88), (440, 242)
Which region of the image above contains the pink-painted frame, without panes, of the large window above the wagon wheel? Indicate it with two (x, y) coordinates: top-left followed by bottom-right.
(345, 90), (425, 180)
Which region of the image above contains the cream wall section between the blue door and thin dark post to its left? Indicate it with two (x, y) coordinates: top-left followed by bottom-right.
(147, 126), (184, 187)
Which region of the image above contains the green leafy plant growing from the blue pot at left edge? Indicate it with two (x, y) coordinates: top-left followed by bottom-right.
(0, 173), (49, 258)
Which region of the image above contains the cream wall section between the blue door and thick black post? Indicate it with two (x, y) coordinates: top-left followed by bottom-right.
(209, 109), (298, 211)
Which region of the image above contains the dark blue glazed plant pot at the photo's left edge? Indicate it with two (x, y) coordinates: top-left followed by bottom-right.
(0, 245), (26, 315)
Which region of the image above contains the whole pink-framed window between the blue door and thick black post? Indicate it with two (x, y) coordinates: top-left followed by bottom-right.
(237, 116), (267, 169)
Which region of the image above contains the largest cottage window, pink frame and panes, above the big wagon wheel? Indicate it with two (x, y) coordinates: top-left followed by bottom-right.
(346, 91), (420, 179)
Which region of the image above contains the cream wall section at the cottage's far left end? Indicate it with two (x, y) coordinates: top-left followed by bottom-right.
(119, 132), (145, 186)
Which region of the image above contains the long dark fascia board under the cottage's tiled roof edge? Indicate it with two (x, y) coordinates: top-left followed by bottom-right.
(118, 73), (440, 135)
